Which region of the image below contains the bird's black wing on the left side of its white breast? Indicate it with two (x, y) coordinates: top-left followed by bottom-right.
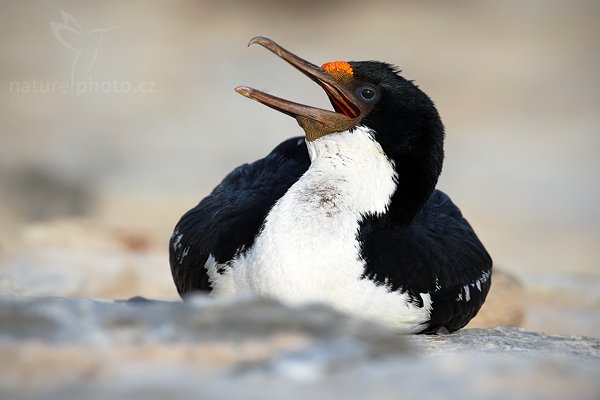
(169, 137), (310, 296)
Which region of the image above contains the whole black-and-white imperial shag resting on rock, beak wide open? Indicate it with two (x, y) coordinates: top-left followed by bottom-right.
(170, 37), (492, 333)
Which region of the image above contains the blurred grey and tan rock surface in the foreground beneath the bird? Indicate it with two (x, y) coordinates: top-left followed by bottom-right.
(0, 297), (600, 400)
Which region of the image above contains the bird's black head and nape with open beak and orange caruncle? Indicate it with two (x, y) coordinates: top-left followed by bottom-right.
(236, 37), (444, 222)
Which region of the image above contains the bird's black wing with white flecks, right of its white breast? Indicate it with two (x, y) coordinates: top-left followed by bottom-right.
(359, 190), (492, 332)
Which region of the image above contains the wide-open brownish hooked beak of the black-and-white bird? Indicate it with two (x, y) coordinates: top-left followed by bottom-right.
(235, 36), (363, 141)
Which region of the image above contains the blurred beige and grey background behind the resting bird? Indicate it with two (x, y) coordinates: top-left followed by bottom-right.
(0, 0), (600, 337)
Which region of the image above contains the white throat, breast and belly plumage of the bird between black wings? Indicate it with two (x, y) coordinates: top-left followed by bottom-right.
(206, 127), (431, 332)
